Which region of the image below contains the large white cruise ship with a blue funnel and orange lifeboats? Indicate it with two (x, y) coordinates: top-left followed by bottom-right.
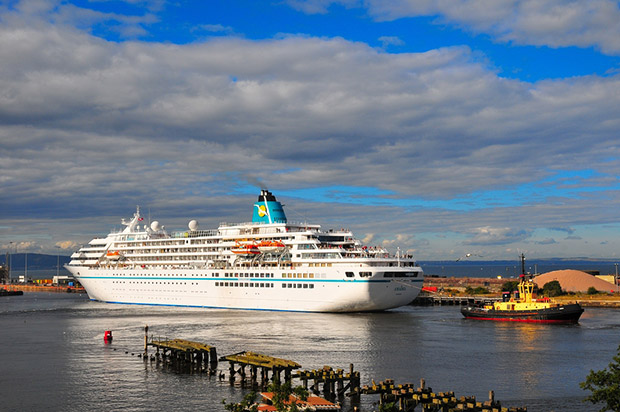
(66, 190), (423, 312)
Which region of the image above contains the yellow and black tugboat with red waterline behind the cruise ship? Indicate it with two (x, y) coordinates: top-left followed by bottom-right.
(461, 254), (583, 324)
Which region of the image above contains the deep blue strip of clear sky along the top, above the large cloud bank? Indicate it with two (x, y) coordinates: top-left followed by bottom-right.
(72, 0), (620, 81)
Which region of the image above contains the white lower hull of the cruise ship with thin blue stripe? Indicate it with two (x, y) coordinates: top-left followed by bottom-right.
(68, 266), (423, 312)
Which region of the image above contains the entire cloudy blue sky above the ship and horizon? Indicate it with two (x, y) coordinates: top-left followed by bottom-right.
(0, 0), (620, 260)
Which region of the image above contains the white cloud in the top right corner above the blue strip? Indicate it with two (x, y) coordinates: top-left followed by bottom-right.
(318, 0), (620, 55)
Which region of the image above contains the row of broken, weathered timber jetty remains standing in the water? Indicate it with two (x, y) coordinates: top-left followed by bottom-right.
(139, 326), (527, 412)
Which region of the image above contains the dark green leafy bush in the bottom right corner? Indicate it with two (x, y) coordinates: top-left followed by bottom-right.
(579, 346), (620, 412)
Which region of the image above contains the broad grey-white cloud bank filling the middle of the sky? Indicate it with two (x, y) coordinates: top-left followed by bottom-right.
(0, 10), (620, 256)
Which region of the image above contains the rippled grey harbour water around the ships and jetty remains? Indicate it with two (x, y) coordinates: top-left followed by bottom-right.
(0, 293), (620, 412)
